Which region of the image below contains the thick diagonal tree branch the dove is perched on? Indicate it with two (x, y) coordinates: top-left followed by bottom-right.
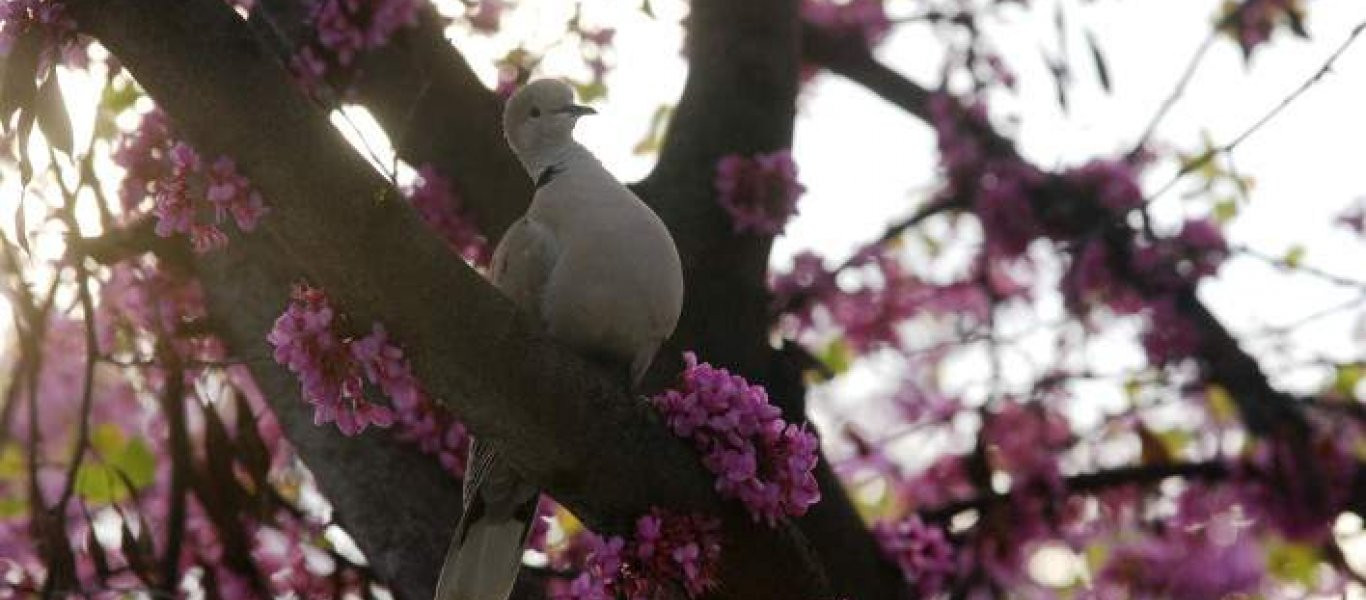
(68, 0), (828, 599)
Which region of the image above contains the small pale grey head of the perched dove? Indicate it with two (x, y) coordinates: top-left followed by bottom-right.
(503, 79), (597, 171)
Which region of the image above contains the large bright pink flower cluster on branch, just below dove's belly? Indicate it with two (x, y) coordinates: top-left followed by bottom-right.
(650, 353), (821, 525)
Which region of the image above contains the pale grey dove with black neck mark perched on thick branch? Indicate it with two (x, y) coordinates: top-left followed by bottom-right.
(436, 79), (683, 600)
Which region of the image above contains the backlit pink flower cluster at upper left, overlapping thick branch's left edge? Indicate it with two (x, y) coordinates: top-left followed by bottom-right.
(113, 111), (266, 251)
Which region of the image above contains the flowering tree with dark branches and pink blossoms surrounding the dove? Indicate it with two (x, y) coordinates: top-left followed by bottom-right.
(0, 0), (1366, 599)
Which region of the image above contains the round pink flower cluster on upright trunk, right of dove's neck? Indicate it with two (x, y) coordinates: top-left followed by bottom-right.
(716, 150), (806, 235)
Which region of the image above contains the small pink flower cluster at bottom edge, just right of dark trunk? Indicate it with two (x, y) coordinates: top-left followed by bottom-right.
(873, 515), (958, 597)
